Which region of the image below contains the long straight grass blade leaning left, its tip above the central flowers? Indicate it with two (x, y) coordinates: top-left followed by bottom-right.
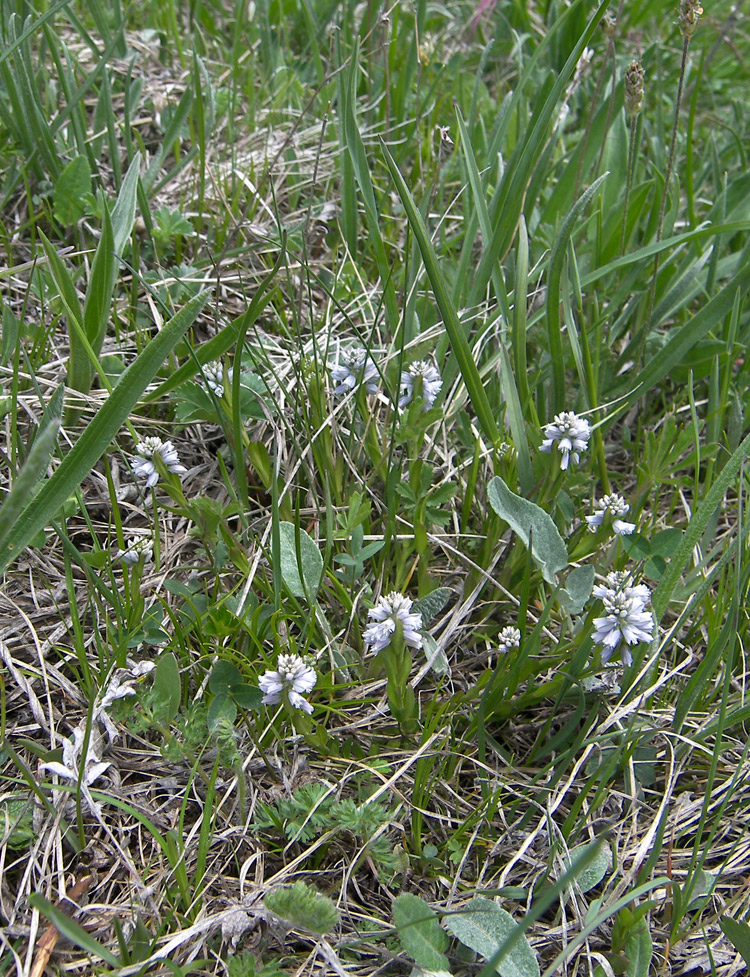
(381, 143), (500, 445)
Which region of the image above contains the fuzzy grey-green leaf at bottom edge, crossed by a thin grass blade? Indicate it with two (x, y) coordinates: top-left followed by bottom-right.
(445, 896), (539, 977)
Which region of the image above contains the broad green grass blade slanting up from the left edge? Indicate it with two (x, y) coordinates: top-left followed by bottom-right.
(0, 292), (210, 573)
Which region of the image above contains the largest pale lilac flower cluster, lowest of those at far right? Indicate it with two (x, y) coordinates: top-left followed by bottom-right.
(593, 572), (656, 665)
